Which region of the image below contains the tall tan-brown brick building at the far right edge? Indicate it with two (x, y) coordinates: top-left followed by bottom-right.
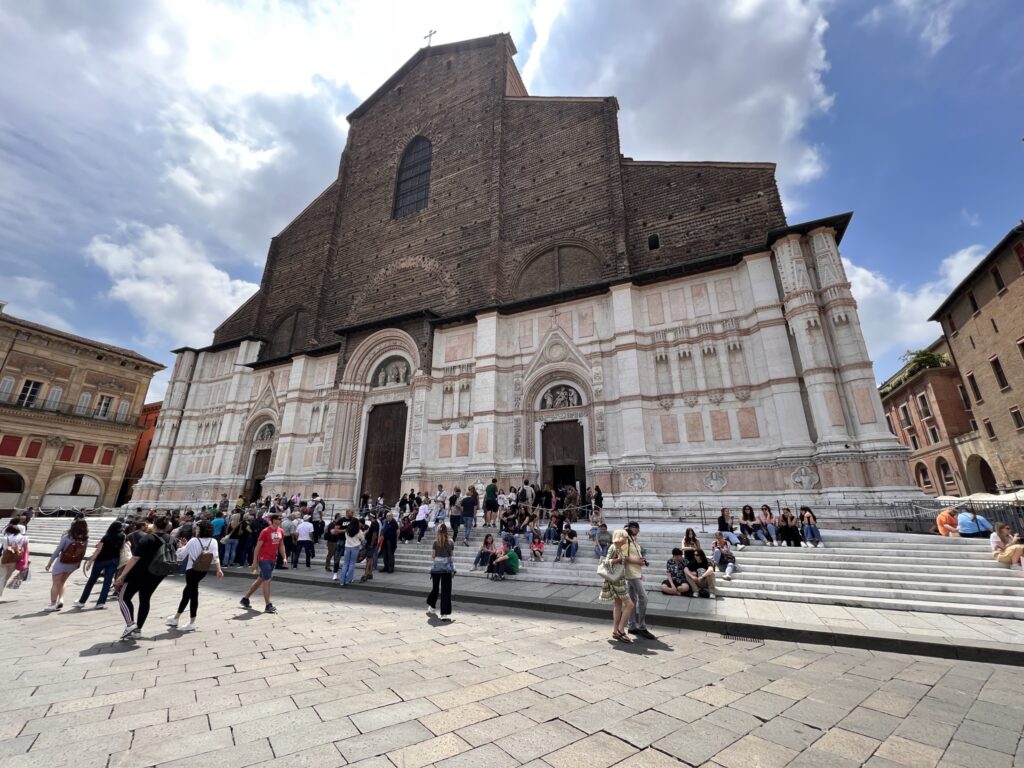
(931, 223), (1024, 493)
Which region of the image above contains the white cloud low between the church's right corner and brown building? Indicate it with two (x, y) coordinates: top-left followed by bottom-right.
(843, 245), (986, 373)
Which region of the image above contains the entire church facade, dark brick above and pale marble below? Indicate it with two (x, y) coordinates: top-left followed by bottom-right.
(132, 35), (918, 508)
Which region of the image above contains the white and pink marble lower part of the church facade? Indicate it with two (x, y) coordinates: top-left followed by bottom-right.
(132, 228), (921, 508)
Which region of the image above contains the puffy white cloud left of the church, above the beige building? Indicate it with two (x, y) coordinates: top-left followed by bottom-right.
(85, 223), (257, 346)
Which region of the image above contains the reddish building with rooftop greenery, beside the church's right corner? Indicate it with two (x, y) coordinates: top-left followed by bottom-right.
(879, 338), (974, 496)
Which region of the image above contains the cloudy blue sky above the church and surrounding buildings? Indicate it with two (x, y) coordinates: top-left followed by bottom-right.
(0, 0), (1024, 399)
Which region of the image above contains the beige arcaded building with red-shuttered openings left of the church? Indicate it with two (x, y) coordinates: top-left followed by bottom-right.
(0, 302), (163, 513)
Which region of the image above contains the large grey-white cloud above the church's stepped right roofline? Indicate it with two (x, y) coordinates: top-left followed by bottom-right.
(524, 0), (833, 195)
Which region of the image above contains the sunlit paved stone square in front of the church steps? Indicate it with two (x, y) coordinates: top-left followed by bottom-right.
(0, 573), (1024, 768)
